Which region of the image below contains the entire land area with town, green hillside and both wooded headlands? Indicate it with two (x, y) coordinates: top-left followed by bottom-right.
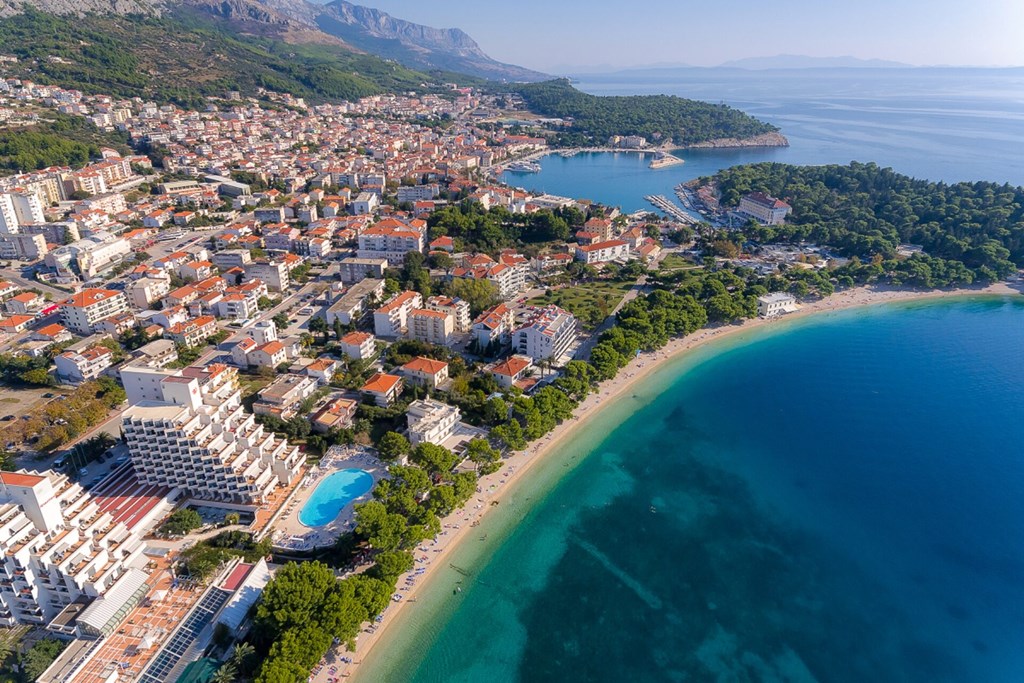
(0, 5), (1024, 683)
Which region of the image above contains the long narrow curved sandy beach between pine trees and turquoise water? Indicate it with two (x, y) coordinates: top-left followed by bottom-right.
(312, 284), (1020, 683)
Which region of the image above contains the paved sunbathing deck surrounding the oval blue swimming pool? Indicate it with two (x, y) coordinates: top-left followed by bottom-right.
(270, 445), (387, 550)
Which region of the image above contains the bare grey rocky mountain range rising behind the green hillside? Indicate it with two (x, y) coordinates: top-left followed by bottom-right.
(0, 0), (550, 81)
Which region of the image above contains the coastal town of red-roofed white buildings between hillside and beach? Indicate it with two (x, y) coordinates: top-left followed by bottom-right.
(0, 57), (1024, 683)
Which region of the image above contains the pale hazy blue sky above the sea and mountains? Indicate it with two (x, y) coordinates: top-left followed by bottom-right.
(353, 0), (1024, 71)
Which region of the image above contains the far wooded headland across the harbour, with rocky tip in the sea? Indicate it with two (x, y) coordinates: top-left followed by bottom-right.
(516, 79), (778, 146)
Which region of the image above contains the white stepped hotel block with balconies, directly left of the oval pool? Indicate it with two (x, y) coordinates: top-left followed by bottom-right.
(122, 365), (303, 505)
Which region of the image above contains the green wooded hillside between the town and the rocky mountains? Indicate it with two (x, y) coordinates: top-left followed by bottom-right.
(0, 9), (430, 109)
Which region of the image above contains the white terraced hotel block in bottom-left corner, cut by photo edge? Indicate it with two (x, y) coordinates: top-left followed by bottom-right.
(0, 468), (178, 637)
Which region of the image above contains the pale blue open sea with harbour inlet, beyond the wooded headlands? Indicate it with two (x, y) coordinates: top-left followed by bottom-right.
(504, 69), (1024, 211)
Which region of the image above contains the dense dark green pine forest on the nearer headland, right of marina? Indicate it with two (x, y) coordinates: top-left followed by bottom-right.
(713, 163), (1024, 287)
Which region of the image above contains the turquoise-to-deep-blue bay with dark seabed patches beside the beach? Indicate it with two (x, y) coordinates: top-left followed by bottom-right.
(382, 298), (1024, 683)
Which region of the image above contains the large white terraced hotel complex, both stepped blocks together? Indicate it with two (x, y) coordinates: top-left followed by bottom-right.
(0, 365), (303, 639)
